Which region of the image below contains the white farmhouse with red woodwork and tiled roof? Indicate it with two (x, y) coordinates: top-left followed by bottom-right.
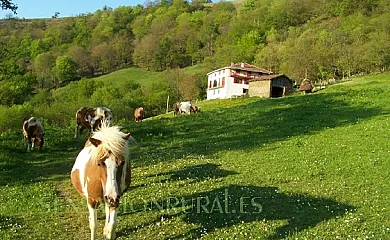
(207, 63), (272, 100)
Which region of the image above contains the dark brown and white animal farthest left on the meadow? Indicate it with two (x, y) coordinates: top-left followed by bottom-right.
(23, 117), (45, 152)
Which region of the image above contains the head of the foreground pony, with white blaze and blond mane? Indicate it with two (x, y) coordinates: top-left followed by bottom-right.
(89, 124), (130, 207)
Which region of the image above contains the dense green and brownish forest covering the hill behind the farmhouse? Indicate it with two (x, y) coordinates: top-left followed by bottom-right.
(0, 0), (390, 106)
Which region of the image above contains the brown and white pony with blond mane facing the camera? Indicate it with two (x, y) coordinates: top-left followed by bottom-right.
(71, 123), (131, 239)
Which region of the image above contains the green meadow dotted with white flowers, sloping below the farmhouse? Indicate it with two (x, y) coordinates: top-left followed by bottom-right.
(0, 74), (390, 239)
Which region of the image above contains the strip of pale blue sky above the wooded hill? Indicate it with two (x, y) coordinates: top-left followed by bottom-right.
(0, 0), (224, 19)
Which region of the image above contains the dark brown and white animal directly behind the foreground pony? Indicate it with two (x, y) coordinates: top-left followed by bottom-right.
(74, 107), (112, 138)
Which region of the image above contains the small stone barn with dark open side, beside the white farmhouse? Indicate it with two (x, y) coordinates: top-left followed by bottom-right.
(248, 74), (293, 98)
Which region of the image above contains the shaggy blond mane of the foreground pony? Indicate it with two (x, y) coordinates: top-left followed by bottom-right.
(92, 122), (129, 160)
